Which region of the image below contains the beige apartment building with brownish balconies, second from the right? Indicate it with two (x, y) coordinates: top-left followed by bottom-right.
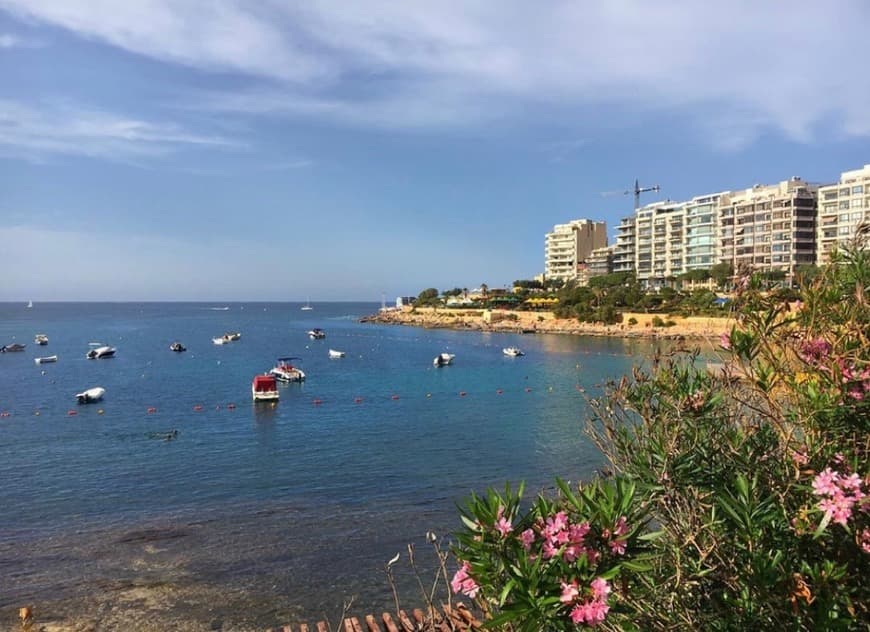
(714, 177), (818, 279)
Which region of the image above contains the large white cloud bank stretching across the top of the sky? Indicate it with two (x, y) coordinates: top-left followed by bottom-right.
(0, 0), (870, 147)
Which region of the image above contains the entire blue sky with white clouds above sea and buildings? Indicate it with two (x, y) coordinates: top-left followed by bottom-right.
(0, 0), (870, 302)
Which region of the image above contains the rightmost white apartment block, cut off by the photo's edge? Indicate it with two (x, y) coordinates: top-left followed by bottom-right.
(816, 165), (870, 265)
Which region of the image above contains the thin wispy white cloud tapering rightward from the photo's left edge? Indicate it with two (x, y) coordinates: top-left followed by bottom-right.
(0, 99), (238, 162)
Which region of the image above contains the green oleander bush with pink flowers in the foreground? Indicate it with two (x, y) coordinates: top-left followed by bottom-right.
(452, 239), (870, 630)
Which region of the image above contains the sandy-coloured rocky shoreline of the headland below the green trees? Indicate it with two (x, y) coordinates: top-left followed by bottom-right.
(363, 307), (734, 339)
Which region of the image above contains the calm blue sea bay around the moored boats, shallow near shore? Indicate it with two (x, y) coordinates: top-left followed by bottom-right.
(0, 302), (654, 630)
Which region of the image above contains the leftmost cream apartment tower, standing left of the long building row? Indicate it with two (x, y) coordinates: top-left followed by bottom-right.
(544, 219), (607, 281)
